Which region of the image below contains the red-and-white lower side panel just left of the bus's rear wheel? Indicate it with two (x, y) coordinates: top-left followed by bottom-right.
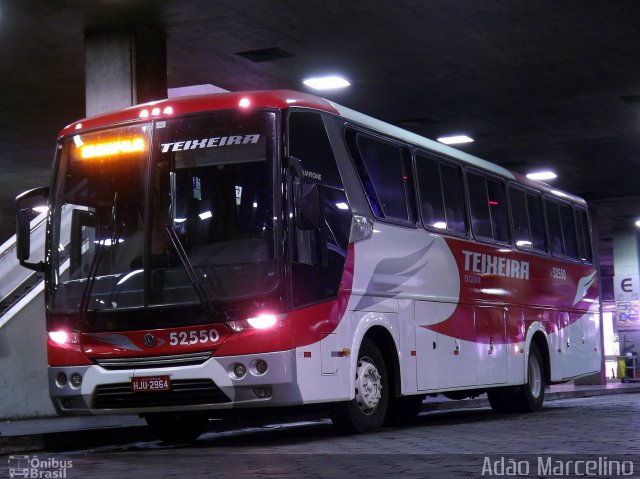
(475, 306), (507, 385)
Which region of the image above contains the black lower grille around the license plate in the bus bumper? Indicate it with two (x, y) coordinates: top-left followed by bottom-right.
(93, 379), (230, 409)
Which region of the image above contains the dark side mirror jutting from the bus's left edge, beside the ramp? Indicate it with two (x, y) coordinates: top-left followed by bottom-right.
(16, 187), (49, 271)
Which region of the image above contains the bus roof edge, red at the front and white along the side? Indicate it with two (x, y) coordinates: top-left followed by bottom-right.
(59, 90), (586, 205)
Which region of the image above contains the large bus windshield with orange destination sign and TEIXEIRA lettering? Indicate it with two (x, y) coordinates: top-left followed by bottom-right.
(48, 111), (278, 312)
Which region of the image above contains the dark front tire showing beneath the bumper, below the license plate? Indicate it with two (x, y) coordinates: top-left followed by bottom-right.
(144, 413), (209, 444)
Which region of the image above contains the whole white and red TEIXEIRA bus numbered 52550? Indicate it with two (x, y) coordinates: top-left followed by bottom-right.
(17, 91), (601, 440)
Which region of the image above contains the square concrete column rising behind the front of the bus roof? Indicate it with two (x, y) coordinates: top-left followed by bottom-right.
(84, 26), (167, 116)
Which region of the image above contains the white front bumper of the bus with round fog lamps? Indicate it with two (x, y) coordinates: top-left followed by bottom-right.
(49, 350), (302, 415)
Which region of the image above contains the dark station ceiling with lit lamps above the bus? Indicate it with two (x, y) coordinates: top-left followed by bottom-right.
(0, 0), (640, 280)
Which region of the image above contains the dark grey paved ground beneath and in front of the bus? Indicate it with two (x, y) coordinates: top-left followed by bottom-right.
(5, 392), (640, 479)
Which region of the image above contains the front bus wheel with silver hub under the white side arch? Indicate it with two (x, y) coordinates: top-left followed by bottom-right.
(331, 338), (389, 434)
